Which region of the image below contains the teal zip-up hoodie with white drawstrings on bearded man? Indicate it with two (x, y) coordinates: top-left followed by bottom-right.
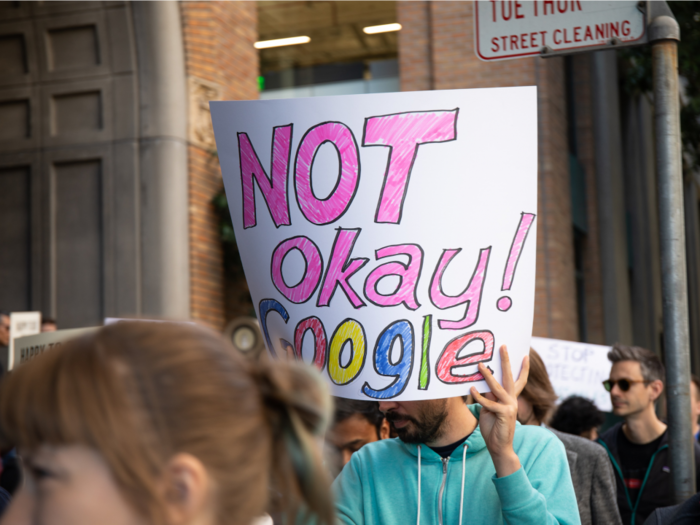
(333, 405), (581, 525)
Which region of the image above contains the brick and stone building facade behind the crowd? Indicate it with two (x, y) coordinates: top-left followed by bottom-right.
(0, 0), (700, 367)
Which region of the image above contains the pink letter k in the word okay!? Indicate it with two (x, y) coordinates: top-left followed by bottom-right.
(316, 228), (369, 308)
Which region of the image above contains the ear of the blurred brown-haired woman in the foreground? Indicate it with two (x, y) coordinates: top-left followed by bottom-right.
(161, 453), (214, 525)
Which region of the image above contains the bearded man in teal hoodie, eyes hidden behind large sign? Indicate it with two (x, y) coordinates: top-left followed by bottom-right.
(333, 347), (580, 525)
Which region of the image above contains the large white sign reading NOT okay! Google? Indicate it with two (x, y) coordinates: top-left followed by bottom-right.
(211, 87), (537, 400)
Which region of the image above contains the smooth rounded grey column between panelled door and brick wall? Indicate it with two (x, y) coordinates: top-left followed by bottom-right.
(133, 0), (190, 318)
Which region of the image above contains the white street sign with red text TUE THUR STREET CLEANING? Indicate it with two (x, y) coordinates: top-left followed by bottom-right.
(474, 0), (646, 61)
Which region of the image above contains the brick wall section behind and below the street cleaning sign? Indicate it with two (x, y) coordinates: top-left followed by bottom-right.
(397, 0), (578, 340)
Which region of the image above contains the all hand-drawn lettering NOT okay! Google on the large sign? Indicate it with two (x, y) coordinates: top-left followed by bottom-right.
(237, 109), (535, 399)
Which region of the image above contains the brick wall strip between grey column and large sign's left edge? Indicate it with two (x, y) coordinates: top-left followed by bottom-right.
(180, 0), (258, 329)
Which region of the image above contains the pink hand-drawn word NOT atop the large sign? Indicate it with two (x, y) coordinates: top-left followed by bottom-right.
(238, 109), (459, 228)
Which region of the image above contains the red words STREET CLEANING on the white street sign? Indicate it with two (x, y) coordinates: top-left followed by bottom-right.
(491, 20), (632, 53)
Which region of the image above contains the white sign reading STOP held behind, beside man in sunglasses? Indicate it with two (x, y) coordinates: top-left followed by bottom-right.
(532, 337), (612, 412)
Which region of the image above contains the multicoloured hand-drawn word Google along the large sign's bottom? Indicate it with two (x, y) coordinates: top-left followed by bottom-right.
(258, 299), (495, 399)
